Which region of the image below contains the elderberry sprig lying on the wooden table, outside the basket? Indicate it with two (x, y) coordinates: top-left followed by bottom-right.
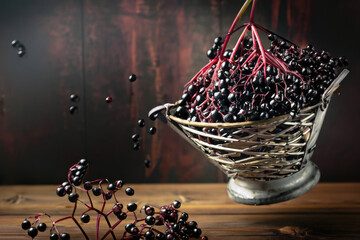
(21, 159), (207, 240)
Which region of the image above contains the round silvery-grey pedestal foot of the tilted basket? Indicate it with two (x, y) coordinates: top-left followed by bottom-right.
(227, 161), (320, 205)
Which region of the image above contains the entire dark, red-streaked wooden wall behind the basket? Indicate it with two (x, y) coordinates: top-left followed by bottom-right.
(0, 0), (360, 184)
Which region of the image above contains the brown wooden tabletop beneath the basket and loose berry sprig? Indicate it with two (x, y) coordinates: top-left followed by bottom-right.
(0, 183), (360, 240)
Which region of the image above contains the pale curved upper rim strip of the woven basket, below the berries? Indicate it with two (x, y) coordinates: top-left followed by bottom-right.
(166, 102), (321, 128)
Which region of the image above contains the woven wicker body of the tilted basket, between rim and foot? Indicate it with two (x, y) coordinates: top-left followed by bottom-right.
(168, 106), (318, 180)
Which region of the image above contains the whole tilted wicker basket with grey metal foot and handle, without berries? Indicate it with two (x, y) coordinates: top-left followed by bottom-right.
(149, 69), (349, 205)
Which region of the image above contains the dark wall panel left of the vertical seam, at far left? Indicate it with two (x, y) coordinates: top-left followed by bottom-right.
(0, 0), (85, 184)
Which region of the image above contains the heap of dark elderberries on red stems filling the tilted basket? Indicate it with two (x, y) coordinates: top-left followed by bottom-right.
(172, 23), (347, 123)
